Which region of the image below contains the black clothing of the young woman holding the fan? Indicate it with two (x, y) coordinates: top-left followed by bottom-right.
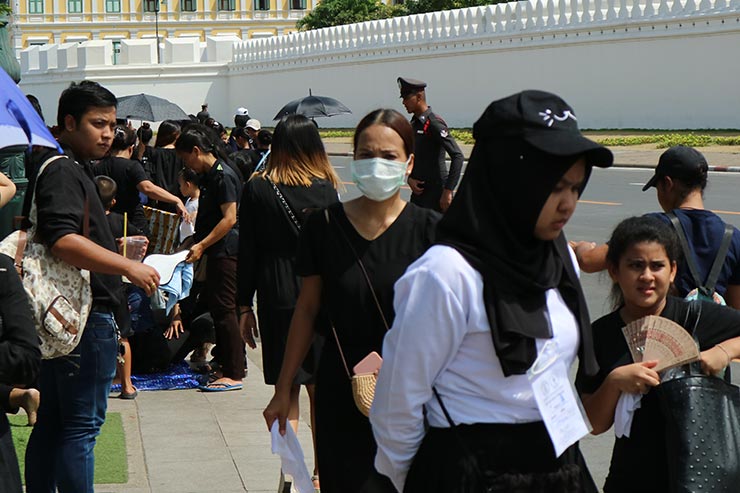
(576, 296), (740, 493)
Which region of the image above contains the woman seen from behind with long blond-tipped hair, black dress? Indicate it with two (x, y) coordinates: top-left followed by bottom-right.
(237, 115), (339, 488)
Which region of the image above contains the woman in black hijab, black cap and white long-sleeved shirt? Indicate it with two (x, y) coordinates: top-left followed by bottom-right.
(370, 91), (612, 493)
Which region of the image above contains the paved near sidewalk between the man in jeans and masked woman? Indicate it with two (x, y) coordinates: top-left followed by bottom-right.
(95, 344), (313, 493)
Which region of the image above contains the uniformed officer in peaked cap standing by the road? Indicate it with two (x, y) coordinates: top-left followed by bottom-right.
(398, 77), (463, 212)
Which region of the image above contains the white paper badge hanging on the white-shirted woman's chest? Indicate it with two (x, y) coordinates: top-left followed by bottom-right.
(527, 340), (592, 457)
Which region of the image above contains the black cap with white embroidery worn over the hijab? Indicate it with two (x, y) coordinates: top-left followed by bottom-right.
(473, 90), (614, 168)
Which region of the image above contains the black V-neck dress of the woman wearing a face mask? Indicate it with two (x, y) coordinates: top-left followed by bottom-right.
(297, 204), (440, 493)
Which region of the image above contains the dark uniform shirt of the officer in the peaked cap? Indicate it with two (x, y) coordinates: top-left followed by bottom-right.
(411, 107), (463, 190)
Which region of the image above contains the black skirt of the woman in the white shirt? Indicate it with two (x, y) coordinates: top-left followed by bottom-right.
(404, 422), (598, 493)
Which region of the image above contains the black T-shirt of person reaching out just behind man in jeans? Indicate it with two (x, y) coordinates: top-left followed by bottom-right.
(95, 157), (149, 235)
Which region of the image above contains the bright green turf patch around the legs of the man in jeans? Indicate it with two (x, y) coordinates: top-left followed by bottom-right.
(8, 413), (128, 484)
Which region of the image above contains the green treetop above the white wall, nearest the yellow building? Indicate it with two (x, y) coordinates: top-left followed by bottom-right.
(297, 0), (406, 31)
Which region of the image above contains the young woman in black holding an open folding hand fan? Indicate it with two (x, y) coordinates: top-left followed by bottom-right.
(576, 217), (740, 493)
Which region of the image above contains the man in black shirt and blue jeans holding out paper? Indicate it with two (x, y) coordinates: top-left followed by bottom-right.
(25, 81), (159, 493)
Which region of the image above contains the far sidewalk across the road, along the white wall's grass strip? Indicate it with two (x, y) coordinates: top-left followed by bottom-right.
(324, 138), (740, 172)
